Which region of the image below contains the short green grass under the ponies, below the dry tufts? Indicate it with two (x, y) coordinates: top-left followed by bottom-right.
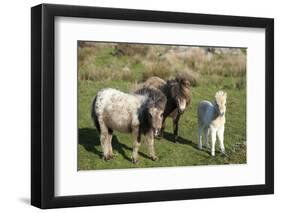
(78, 77), (246, 170)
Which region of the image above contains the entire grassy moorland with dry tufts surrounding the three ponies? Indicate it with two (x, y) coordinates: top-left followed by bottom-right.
(78, 42), (247, 170)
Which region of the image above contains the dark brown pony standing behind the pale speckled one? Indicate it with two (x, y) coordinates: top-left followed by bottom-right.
(142, 73), (191, 142)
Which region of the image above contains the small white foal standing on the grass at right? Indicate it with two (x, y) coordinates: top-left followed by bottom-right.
(197, 91), (227, 156)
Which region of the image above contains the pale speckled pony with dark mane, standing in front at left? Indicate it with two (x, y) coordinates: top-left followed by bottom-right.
(91, 88), (167, 163)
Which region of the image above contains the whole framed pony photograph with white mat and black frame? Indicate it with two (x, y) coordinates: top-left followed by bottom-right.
(31, 4), (274, 208)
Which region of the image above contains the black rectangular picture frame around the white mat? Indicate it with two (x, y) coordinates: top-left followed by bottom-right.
(31, 4), (274, 209)
